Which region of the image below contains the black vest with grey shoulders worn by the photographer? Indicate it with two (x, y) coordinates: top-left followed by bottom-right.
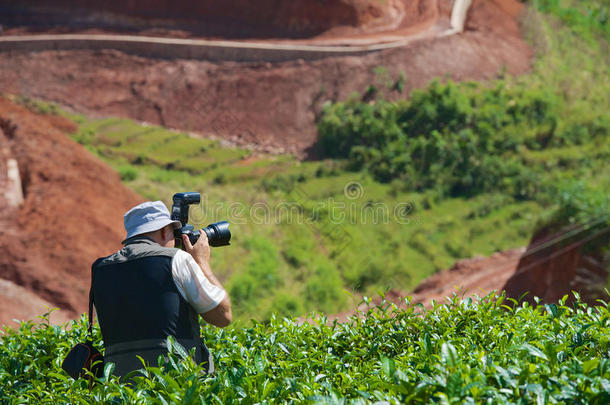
(91, 237), (213, 376)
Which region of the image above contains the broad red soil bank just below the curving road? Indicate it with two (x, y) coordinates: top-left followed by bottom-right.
(0, 0), (532, 154)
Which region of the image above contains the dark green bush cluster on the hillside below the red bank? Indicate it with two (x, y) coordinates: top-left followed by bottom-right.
(318, 76), (608, 199)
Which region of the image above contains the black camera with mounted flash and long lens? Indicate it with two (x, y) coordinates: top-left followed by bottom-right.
(172, 192), (231, 247)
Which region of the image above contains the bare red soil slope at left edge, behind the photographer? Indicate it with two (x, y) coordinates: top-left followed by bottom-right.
(0, 97), (141, 324)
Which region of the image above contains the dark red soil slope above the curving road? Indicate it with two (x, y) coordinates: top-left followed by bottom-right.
(3, 0), (428, 38)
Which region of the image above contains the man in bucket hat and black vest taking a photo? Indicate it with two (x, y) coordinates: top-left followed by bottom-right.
(92, 201), (231, 376)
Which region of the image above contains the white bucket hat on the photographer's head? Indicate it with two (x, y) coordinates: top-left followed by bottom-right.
(121, 201), (182, 244)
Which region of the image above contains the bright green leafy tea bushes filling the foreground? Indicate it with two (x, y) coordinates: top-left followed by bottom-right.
(0, 295), (610, 405)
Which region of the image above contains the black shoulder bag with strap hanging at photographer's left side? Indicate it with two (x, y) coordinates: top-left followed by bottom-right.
(61, 269), (104, 380)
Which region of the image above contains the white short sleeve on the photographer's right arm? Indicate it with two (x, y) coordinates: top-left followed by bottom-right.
(172, 250), (226, 314)
